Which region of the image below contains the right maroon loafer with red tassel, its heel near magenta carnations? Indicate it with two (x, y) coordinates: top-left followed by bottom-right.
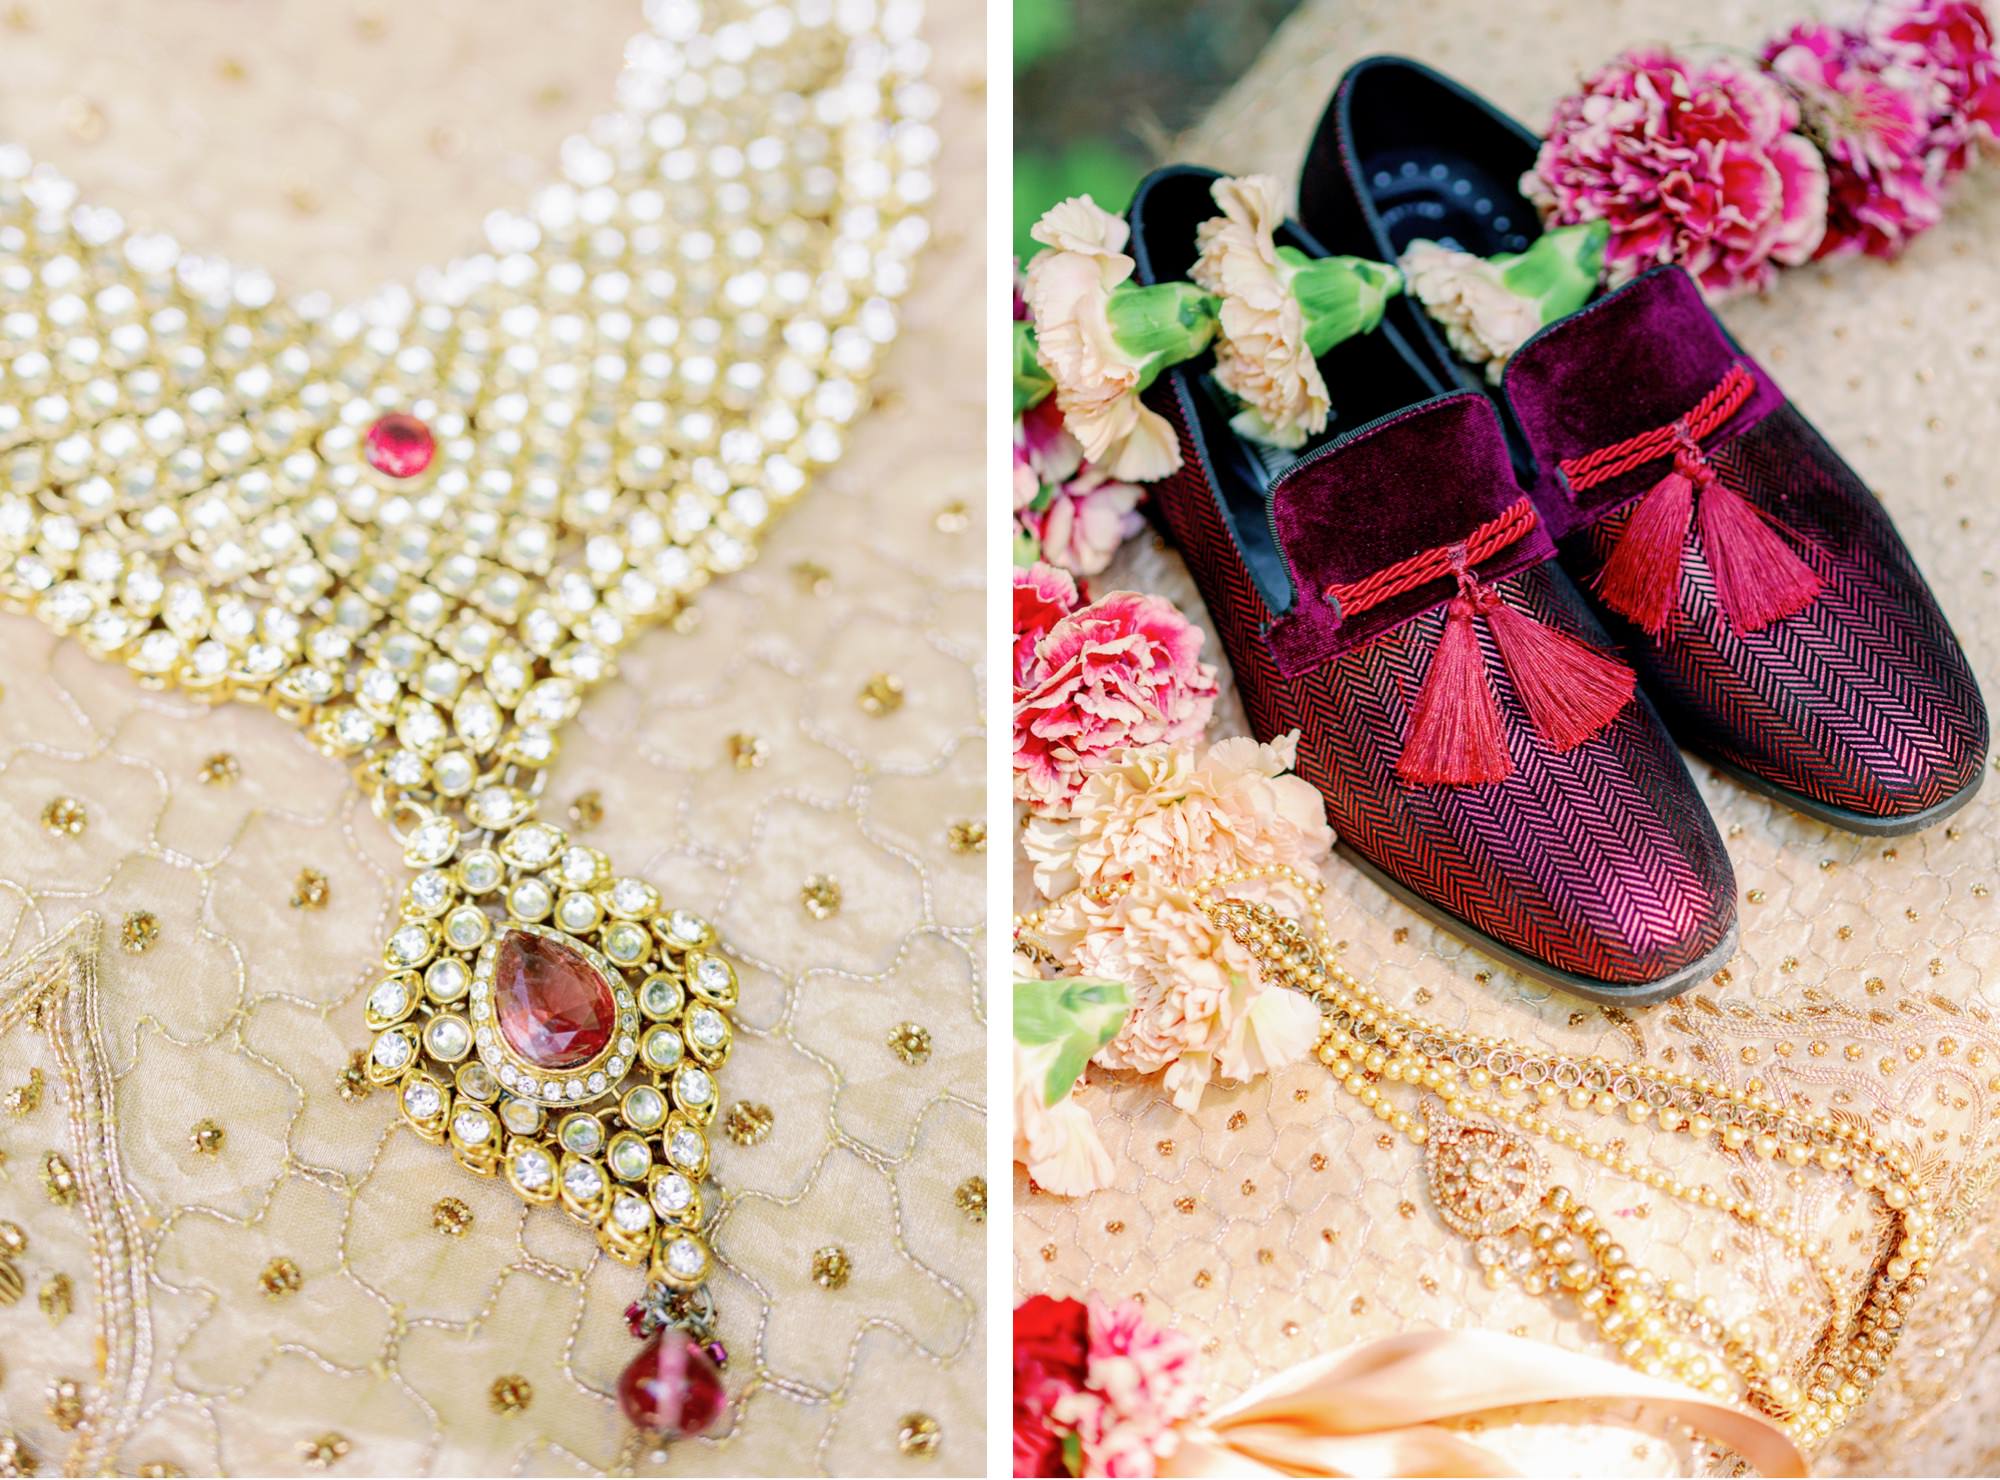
(1300, 56), (1988, 834)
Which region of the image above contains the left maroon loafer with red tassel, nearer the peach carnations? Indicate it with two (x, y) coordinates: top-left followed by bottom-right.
(1130, 168), (1736, 1004)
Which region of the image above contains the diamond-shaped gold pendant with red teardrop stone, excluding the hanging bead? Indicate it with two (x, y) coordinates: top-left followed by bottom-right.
(364, 788), (736, 1292)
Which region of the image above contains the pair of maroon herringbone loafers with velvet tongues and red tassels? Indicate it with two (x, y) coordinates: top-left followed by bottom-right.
(1130, 58), (1988, 1004)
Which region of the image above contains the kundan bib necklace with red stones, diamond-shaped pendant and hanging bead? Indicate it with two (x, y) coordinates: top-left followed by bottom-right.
(0, 0), (936, 1438)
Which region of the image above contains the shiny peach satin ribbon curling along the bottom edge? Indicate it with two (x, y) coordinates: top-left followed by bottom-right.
(1160, 1330), (1806, 1478)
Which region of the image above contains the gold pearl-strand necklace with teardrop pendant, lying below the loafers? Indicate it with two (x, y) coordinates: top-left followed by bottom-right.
(1014, 866), (1938, 1446)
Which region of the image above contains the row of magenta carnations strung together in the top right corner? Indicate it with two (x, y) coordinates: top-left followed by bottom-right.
(1520, 0), (2000, 298)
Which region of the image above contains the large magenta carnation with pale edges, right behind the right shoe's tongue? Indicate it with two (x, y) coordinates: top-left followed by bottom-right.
(1520, 50), (1826, 298)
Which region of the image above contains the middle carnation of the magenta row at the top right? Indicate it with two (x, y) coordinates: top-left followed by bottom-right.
(1764, 24), (1944, 258)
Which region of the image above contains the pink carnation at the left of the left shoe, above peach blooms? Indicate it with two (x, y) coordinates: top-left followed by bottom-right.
(1014, 584), (1216, 816)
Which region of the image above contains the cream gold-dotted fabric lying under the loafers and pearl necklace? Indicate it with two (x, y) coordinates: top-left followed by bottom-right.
(1016, 0), (2000, 1474)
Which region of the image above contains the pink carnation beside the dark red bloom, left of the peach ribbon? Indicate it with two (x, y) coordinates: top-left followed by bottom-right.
(1050, 1294), (1202, 1478)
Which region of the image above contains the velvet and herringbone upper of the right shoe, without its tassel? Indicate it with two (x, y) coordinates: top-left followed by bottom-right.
(1504, 268), (1988, 834)
